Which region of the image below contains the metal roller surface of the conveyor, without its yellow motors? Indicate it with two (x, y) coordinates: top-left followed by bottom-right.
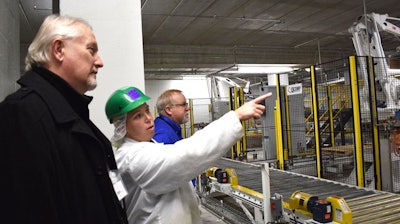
(206, 159), (400, 224)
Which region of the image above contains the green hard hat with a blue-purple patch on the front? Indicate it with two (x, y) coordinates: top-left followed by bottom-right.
(106, 86), (150, 123)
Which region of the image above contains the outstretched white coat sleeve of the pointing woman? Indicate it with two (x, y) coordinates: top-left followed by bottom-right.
(116, 111), (243, 195)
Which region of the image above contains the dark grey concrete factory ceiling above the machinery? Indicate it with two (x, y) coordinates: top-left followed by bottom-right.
(19, 0), (400, 79)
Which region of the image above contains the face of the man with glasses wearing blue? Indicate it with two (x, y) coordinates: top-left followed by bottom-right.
(166, 93), (190, 124)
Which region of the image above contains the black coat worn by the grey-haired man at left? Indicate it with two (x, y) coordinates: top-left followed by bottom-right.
(0, 68), (127, 224)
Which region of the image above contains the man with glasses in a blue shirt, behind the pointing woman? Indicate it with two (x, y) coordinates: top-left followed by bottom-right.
(153, 89), (196, 185)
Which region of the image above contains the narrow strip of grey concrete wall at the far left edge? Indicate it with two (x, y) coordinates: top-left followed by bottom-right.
(0, 0), (20, 101)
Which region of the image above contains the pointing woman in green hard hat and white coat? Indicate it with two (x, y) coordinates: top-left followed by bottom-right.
(106, 87), (271, 224)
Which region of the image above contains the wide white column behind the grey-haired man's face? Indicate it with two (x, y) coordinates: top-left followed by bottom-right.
(60, 0), (144, 138)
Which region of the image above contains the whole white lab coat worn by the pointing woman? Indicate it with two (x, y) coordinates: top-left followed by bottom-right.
(115, 112), (243, 224)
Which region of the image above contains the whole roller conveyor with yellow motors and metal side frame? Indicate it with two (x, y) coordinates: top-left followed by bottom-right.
(200, 158), (400, 224)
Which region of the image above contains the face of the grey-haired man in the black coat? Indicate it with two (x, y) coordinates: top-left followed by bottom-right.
(63, 25), (103, 93)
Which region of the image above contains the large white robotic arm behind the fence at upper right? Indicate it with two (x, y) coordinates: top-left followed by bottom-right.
(349, 13), (400, 110)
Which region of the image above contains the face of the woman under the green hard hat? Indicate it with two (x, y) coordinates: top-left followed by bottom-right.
(126, 103), (154, 142)
